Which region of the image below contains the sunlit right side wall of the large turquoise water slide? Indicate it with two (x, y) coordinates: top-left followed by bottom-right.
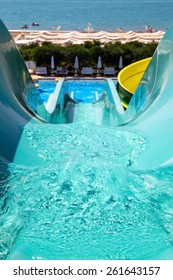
(124, 25), (173, 170)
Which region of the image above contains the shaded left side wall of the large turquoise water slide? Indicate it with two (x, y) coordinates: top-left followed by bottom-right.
(0, 20), (43, 164)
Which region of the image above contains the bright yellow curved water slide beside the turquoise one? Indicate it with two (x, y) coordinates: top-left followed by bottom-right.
(117, 57), (151, 108)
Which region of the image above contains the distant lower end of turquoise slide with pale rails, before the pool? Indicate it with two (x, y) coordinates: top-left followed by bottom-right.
(35, 78), (124, 126)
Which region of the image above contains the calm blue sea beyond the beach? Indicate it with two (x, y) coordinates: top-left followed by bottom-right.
(0, 0), (173, 31)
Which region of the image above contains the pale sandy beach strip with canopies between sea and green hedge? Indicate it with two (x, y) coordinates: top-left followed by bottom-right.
(10, 30), (165, 46)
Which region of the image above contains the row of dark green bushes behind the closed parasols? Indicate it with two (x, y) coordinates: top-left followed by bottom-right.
(19, 41), (157, 69)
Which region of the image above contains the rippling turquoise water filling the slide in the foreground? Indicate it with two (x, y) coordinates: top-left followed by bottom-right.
(0, 123), (173, 260)
